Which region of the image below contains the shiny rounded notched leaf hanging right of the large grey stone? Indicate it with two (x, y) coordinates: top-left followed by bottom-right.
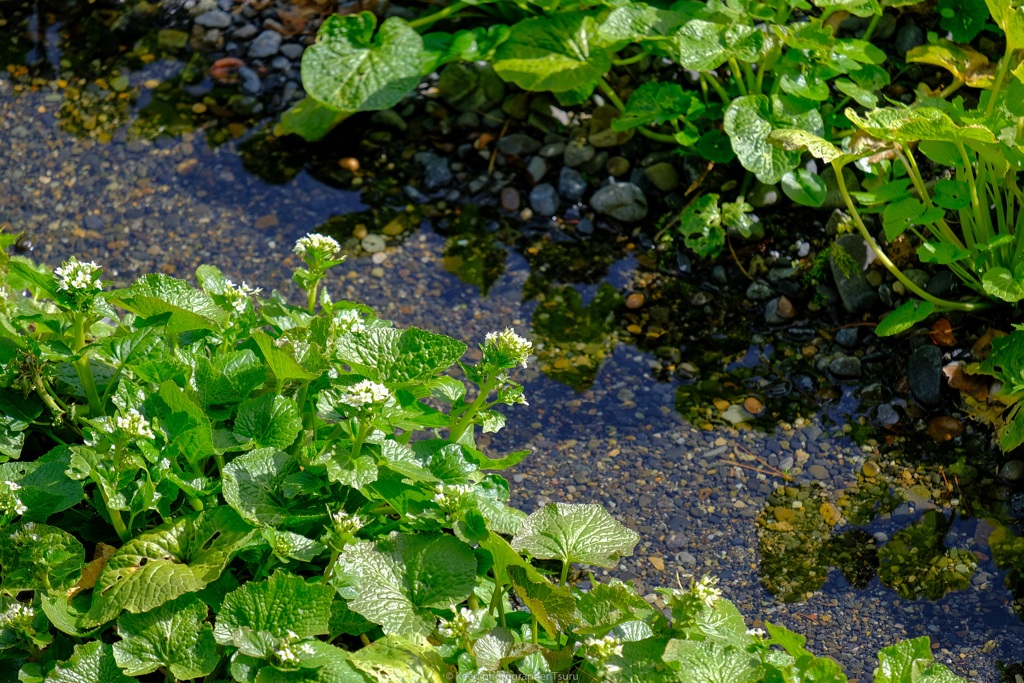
(724, 95), (822, 185)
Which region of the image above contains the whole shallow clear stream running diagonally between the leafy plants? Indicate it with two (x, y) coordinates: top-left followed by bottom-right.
(0, 6), (1024, 681)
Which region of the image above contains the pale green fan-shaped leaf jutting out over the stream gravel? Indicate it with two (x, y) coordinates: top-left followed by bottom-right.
(511, 503), (640, 568)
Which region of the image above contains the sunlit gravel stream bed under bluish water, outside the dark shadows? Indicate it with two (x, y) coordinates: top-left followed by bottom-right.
(0, 63), (1024, 682)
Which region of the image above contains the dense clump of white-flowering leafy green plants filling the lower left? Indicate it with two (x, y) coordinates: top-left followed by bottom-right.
(0, 236), (957, 683)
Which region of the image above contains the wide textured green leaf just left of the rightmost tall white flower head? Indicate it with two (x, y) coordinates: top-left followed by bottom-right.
(337, 328), (466, 387)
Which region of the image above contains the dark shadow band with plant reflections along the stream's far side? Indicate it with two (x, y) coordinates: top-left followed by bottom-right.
(0, 2), (1024, 681)
